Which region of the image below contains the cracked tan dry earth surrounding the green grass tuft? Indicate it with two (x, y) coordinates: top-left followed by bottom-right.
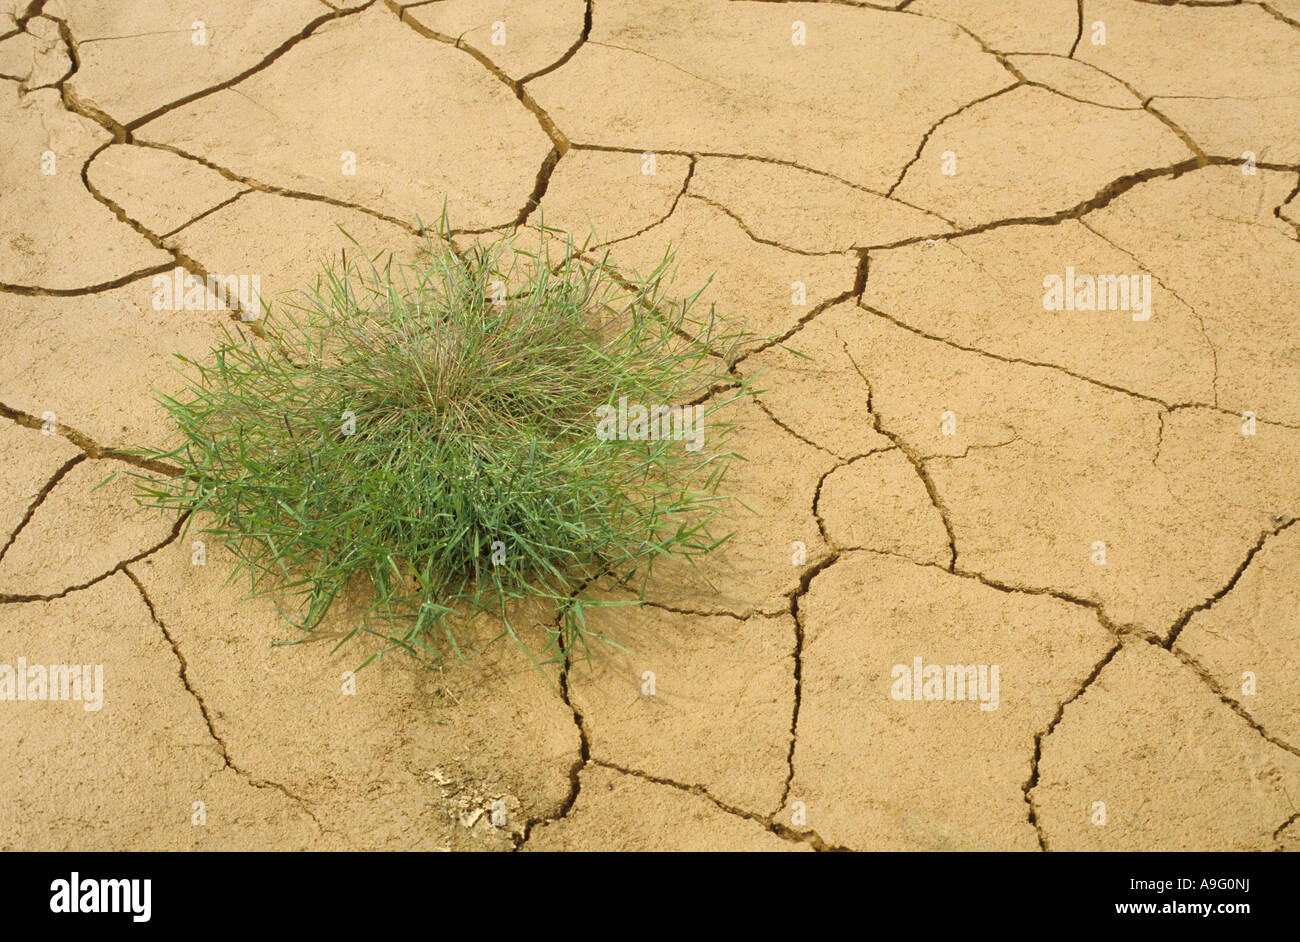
(0, 0), (1300, 850)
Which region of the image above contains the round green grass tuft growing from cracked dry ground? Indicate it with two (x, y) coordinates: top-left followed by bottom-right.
(124, 221), (749, 664)
